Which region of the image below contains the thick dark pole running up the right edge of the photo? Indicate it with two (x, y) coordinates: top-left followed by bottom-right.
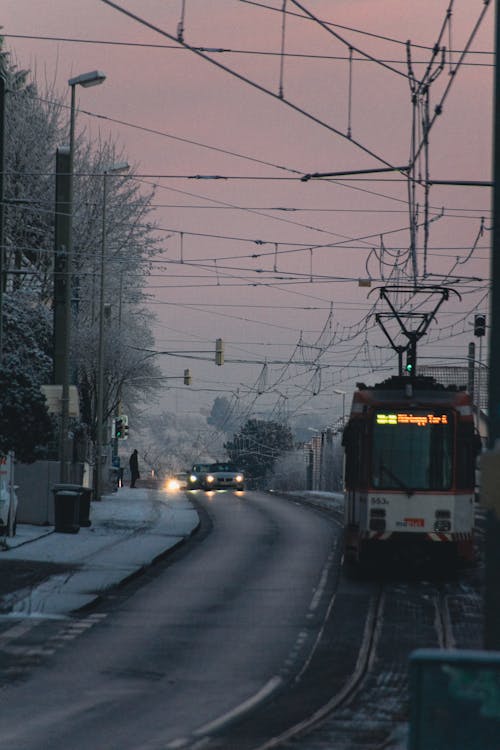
(484, 0), (500, 649)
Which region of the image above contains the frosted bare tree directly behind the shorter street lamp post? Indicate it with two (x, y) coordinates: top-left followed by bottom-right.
(68, 141), (161, 436)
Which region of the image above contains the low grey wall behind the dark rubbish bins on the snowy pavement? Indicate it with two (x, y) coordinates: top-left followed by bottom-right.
(14, 461), (84, 526)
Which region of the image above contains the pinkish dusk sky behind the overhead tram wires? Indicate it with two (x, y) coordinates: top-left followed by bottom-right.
(0, 0), (494, 426)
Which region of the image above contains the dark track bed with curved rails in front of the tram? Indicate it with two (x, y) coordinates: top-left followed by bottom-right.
(186, 495), (481, 750)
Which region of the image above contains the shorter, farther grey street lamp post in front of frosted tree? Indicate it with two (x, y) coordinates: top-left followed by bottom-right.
(95, 162), (129, 500)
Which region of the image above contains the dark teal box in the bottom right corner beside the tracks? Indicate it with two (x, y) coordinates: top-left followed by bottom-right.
(409, 649), (500, 750)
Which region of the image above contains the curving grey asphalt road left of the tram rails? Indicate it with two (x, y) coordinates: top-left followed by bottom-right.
(1, 492), (338, 750)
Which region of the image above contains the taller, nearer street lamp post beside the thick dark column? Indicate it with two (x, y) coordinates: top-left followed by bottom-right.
(60, 70), (106, 482)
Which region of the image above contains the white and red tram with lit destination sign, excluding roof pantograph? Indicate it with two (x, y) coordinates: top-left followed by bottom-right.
(343, 376), (480, 562)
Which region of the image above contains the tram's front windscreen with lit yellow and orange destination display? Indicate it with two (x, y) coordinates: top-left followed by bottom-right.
(371, 412), (453, 490)
